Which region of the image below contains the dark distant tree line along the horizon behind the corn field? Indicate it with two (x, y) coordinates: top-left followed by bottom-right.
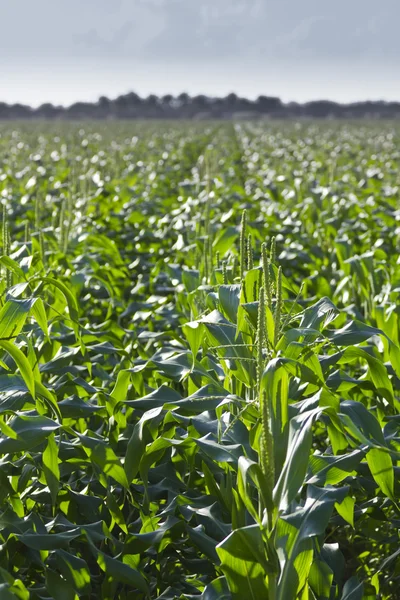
(0, 92), (400, 120)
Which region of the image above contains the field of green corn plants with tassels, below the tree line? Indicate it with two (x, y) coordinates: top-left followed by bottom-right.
(0, 123), (400, 600)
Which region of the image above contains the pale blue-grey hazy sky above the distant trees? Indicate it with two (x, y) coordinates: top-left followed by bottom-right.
(0, 0), (400, 105)
